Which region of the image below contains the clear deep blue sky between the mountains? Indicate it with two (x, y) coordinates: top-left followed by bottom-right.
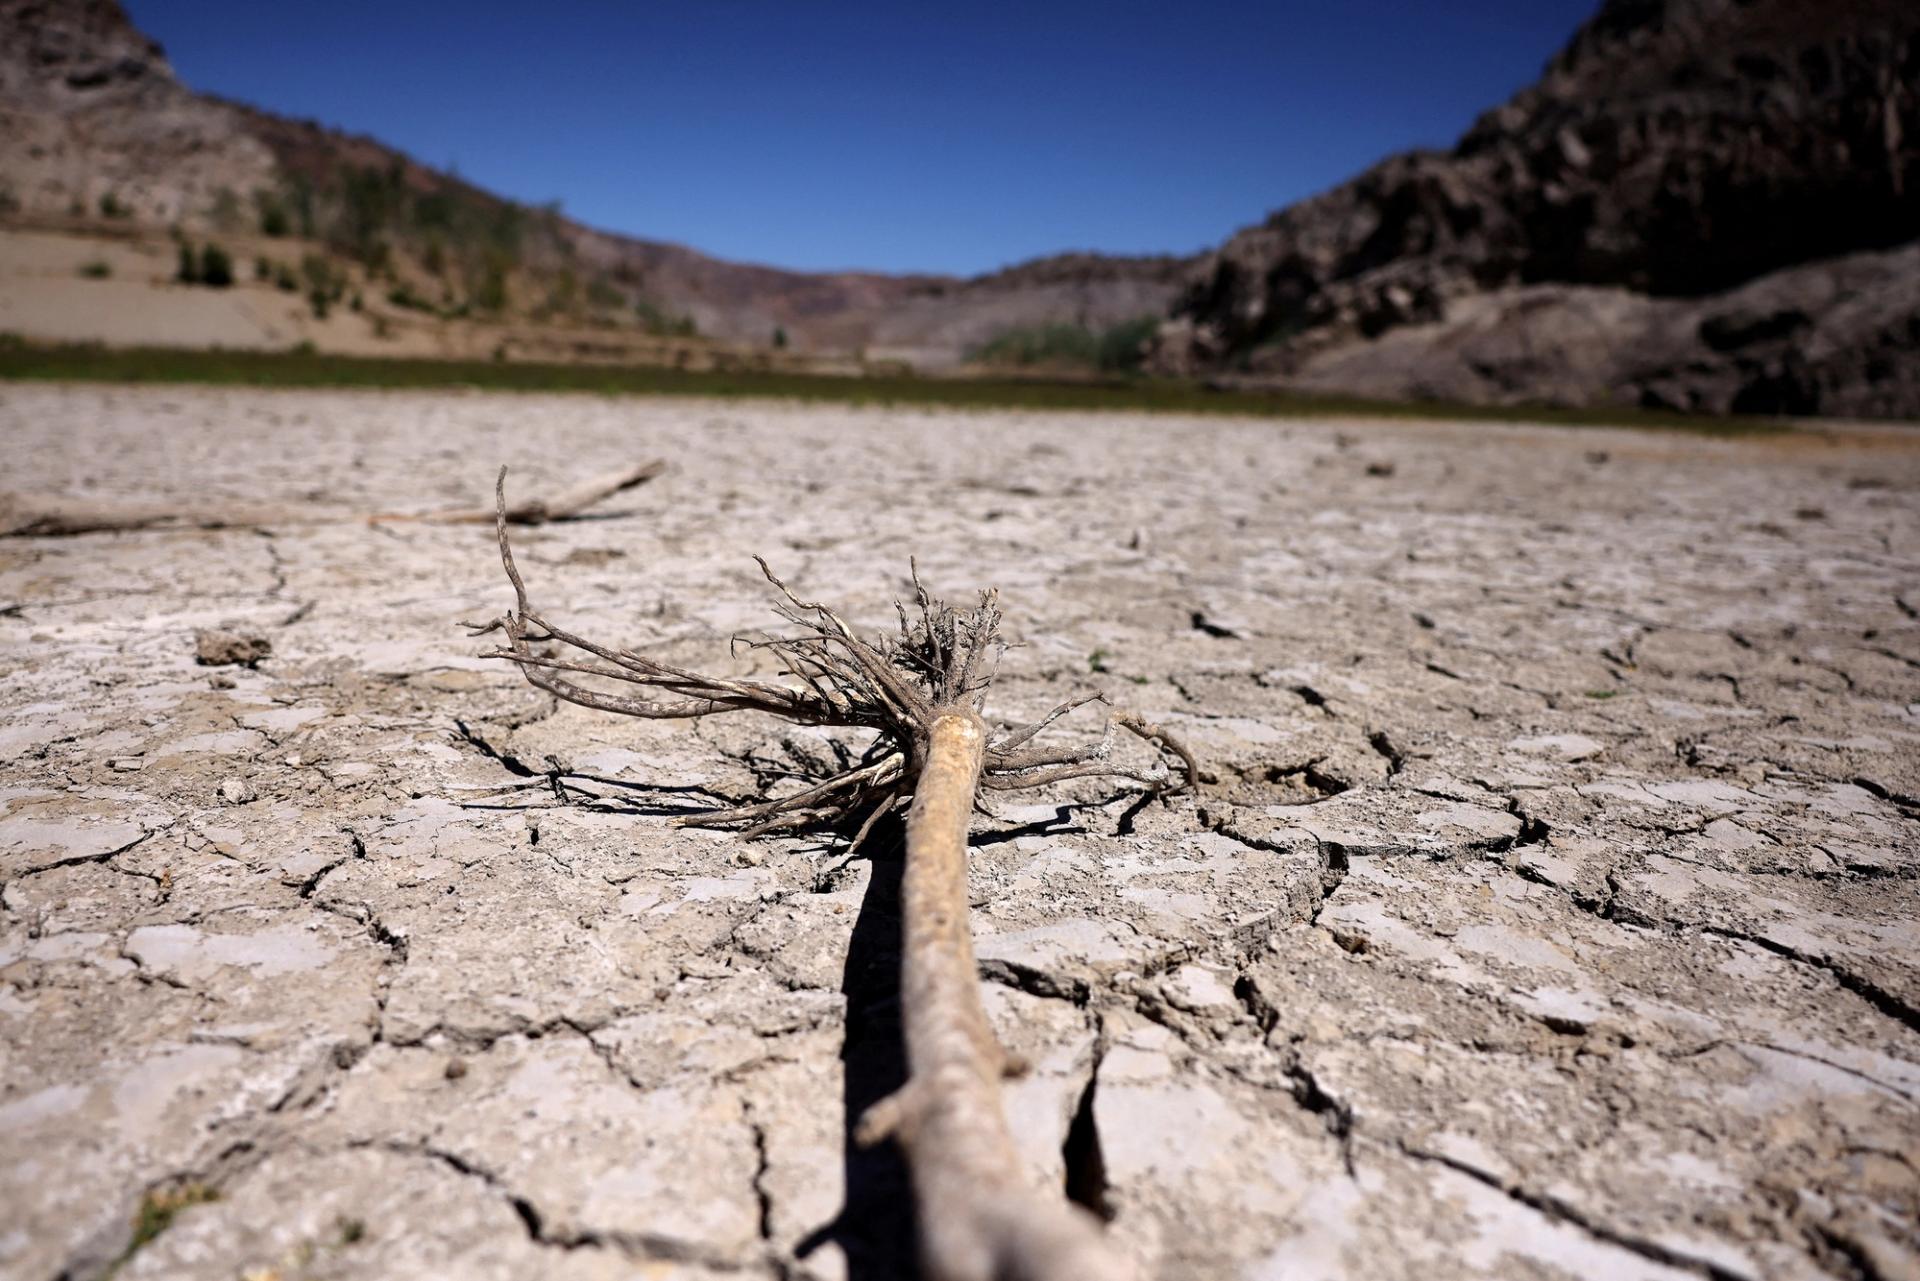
(127, 0), (1597, 273)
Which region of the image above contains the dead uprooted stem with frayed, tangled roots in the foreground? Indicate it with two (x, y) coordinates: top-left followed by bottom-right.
(474, 469), (1196, 1281)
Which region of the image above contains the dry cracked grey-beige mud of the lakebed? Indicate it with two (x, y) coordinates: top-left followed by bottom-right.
(0, 388), (1920, 1281)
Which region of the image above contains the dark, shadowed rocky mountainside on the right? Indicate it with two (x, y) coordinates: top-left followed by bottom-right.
(1156, 0), (1920, 417)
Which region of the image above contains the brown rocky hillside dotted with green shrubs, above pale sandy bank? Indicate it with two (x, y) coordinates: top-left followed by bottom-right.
(0, 0), (1187, 365)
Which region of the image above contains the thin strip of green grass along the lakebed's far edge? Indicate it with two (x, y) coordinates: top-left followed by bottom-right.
(0, 336), (1789, 436)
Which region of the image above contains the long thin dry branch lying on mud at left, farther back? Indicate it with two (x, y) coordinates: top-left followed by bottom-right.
(0, 459), (666, 538)
